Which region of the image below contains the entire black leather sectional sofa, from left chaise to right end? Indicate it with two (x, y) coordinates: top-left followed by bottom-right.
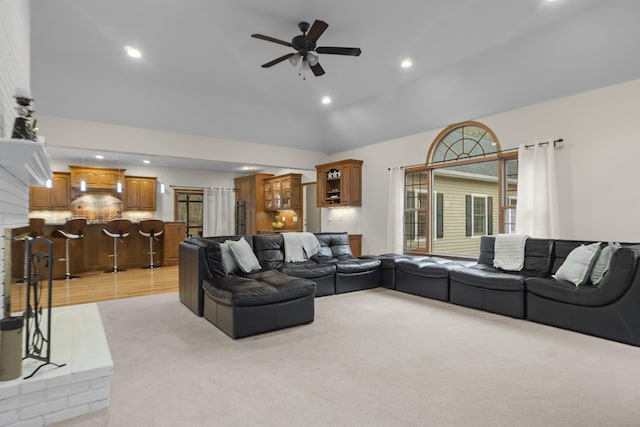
(180, 233), (640, 346)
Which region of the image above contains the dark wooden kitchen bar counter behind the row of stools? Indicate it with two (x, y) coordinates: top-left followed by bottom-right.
(11, 222), (186, 278)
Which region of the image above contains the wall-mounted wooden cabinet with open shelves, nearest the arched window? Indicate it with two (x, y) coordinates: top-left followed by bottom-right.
(316, 159), (362, 208)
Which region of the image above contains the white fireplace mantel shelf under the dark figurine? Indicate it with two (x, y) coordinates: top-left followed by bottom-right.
(0, 138), (53, 186)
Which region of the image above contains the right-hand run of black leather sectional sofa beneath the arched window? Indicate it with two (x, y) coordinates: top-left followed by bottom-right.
(385, 236), (640, 346)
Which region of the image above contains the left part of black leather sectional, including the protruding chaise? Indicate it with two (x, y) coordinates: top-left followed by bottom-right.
(179, 233), (380, 338)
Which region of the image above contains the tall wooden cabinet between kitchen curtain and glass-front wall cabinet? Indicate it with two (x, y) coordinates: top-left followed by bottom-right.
(234, 173), (273, 234)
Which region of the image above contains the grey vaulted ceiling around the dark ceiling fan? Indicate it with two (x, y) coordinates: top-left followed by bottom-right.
(31, 0), (640, 157)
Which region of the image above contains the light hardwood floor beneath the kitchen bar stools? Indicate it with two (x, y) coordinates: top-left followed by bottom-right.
(11, 265), (178, 313)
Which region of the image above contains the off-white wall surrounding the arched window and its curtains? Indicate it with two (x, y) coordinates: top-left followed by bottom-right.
(332, 80), (640, 253)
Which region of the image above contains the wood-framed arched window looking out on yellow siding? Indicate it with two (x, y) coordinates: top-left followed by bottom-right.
(404, 122), (517, 256)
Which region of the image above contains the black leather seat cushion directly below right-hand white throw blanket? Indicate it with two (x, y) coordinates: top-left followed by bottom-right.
(449, 264), (530, 291)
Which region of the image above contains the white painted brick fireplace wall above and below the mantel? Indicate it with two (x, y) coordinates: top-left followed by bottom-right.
(0, 0), (31, 318)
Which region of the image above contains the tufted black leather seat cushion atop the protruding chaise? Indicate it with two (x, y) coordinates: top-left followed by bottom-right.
(202, 270), (315, 306)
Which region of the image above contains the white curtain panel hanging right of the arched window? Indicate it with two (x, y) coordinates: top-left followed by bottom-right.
(516, 141), (559, 238)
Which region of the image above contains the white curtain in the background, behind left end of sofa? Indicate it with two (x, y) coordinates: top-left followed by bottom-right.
(202, 188), (235, 236)
